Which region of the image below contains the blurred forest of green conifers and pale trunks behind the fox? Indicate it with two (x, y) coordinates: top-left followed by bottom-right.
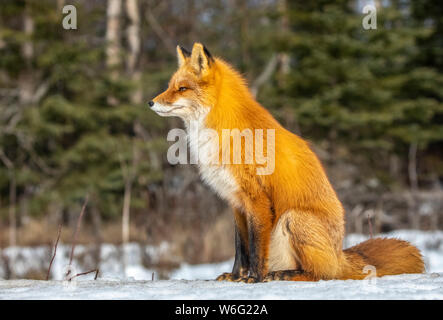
(0, 0), (443, 278)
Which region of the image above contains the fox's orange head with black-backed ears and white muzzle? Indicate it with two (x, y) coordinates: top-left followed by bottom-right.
(148, 43), (217, 120)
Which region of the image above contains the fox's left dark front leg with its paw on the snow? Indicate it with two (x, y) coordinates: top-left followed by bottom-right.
(217, 210), (249, 281)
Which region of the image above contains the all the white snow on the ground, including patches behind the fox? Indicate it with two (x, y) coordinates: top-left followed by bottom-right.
(0, 230), (443, 299)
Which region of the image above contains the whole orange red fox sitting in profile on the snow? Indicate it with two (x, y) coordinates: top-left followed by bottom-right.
(149, 43), (424, 283)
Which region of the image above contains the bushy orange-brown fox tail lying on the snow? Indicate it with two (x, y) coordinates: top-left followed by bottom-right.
(342, 238), (425, 279)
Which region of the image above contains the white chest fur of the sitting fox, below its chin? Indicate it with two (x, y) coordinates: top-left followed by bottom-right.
(187, 115), (239, 206)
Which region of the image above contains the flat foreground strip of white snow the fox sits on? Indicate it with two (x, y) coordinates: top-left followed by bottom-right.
(0, 274), (443, 300)
